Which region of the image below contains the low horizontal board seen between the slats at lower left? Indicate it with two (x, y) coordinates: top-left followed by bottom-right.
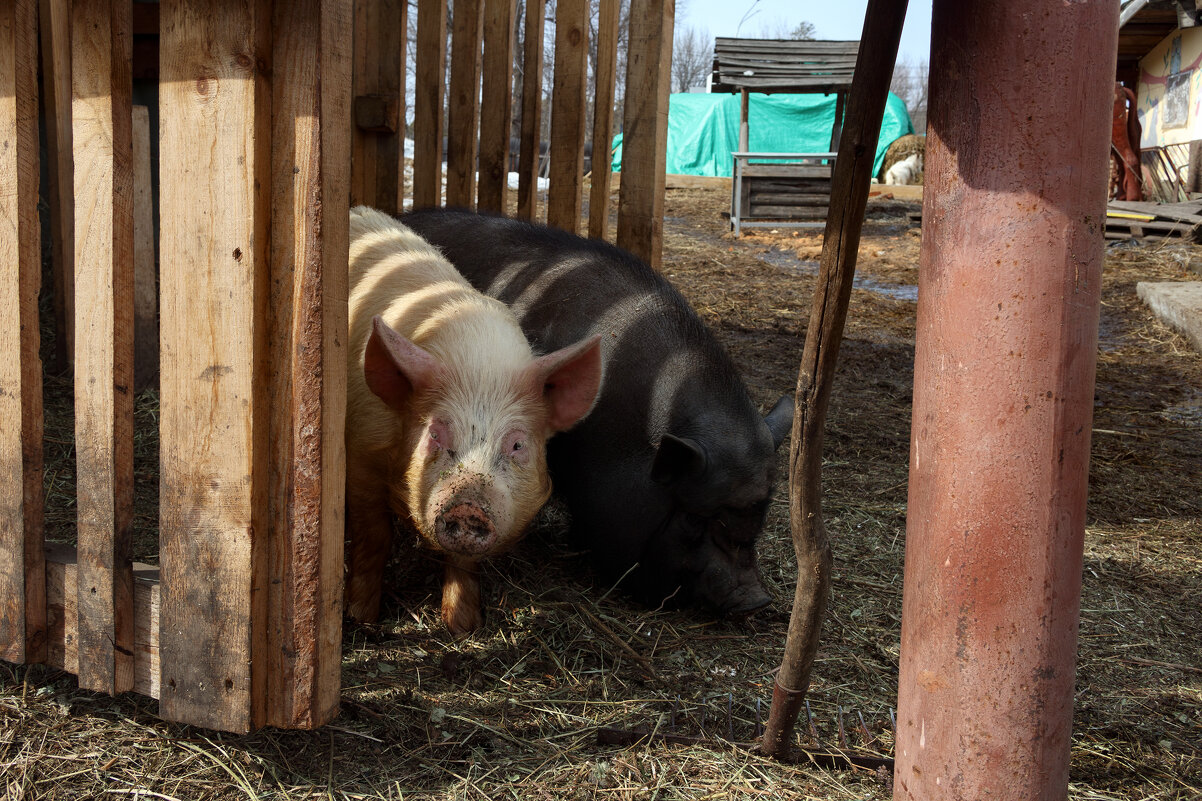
(46, 545), (159, 698)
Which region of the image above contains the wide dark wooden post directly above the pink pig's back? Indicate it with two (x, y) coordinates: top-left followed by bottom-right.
(351, 0), (409, 214)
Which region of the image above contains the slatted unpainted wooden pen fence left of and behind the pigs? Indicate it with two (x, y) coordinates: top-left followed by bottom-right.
(0, 0), (672, 731)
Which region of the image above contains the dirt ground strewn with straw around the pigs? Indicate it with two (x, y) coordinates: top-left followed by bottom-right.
(7, 182), (1202, 801)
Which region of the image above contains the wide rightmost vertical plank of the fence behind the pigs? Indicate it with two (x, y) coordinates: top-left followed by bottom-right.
(618, 0), (676, 269)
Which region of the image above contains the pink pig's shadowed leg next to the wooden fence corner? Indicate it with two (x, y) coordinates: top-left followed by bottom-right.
(346, 475), (392, 623)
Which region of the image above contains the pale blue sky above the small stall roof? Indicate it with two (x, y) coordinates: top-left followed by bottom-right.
(676, 0), (930, 60)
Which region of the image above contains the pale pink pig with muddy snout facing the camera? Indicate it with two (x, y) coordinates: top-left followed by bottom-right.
(346, 206), (601, 634)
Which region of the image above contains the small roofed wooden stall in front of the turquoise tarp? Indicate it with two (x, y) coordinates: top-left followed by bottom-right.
(712, 36), (859, 236)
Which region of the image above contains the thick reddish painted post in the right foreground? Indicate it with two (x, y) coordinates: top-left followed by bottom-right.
(893, 0), (1118, 801)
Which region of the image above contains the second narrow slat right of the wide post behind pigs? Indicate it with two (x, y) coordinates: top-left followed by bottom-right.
(447, 0), (484, 206)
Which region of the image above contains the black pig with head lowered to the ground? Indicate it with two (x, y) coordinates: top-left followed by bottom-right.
(401, 209), (793, 615)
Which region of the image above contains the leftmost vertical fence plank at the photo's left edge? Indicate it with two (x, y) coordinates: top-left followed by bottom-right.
(0, 0), (46, 661)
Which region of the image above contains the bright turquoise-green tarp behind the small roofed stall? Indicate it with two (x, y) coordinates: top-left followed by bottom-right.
(613, 94), (914, 176)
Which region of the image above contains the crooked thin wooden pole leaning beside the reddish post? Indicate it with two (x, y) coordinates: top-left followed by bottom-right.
(760, 0), (906, 757)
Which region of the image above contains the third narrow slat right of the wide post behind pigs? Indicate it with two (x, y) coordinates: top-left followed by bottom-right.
(477, 0), (517, 213)
